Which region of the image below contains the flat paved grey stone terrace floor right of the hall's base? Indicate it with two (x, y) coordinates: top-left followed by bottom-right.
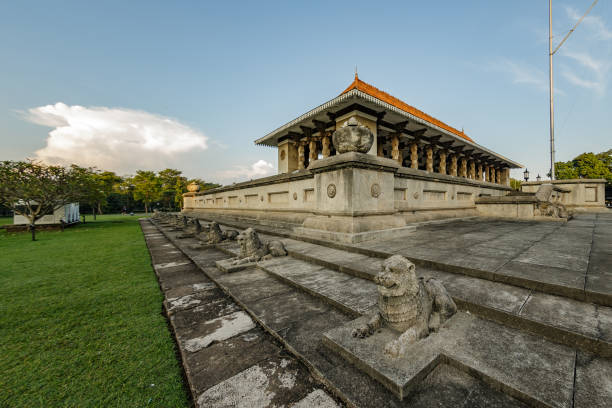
(356, 211), (612, 306)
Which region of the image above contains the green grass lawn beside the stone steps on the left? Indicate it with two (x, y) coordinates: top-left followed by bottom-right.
(0, 215), (189, 407)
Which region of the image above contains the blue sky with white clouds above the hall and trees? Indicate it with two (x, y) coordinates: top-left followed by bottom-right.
(0, 0), (612, 183)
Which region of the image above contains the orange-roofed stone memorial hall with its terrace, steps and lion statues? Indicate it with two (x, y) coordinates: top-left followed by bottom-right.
(141, 75), (612, 408)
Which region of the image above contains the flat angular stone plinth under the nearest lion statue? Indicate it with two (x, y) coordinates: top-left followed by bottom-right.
(322, 312), (575, 406)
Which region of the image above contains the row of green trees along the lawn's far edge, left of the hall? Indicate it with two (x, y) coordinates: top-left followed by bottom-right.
(0, 160), (219, 240)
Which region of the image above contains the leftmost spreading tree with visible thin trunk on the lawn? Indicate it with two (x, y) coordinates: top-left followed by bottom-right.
(0, 160), (88, 241)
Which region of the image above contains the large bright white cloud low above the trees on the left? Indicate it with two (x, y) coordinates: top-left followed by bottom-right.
(22, 102), (208, 173)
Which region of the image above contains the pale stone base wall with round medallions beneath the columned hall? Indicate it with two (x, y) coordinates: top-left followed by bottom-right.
(184, 153), (510, 232)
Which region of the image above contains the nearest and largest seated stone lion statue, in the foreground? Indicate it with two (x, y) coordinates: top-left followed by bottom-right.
(352, 255), (457, 357)
